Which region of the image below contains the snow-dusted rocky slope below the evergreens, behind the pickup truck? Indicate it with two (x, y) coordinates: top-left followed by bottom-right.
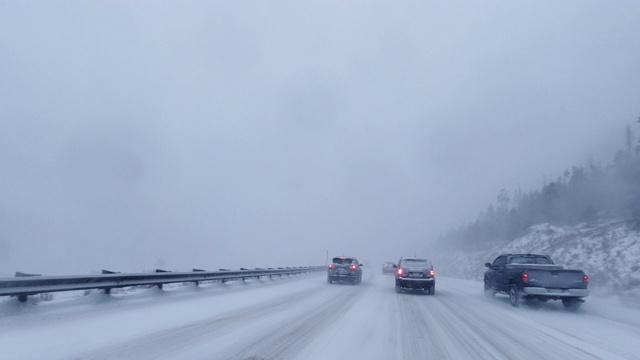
(433, 221), (640, 304)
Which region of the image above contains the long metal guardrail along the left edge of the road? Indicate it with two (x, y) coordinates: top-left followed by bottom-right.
(0, 266), (326, 302)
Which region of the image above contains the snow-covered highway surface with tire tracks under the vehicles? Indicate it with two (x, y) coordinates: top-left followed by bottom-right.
(0, 268), (640, 360)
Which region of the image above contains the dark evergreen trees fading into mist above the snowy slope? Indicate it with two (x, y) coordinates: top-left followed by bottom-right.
(437, 117), (640, 251)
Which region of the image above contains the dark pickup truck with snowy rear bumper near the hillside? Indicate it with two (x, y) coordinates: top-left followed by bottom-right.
(484, 254), (589, 310)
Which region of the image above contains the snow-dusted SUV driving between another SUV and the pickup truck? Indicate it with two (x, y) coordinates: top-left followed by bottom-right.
(395, 257), (436, 295)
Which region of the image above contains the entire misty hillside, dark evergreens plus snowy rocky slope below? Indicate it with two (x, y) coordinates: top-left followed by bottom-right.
(428, 122), (640, 301)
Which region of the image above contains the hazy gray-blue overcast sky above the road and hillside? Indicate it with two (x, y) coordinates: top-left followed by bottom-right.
(0, 0), (640, 275)
